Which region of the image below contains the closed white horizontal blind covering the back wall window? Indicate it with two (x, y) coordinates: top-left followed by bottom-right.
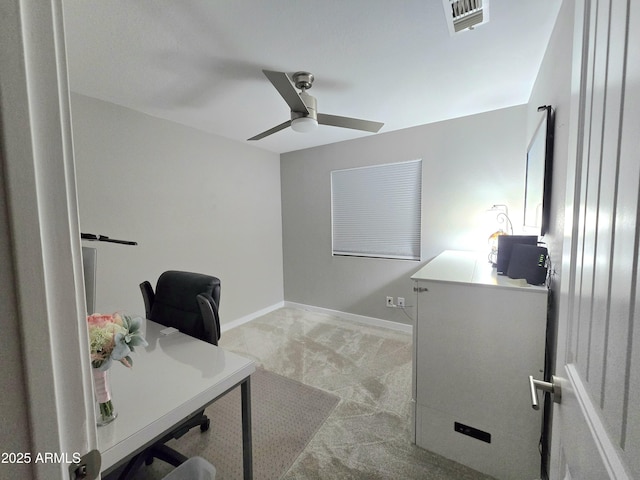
(331, 160), (422, 260)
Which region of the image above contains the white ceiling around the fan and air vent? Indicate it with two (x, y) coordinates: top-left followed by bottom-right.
(63, 0), (561, 153)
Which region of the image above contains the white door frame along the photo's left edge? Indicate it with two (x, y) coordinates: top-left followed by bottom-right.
(0, 0), (99, 479)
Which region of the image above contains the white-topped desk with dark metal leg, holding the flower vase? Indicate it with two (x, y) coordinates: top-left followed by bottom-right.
(98, 320), (255, 478)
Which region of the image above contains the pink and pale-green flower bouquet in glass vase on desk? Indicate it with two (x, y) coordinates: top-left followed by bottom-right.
(87, 313), (148, 425)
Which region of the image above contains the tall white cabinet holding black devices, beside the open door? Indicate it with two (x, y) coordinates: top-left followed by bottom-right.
(411, 251), (547, 480)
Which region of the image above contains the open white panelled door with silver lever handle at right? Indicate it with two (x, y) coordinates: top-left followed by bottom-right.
(550, 0), (640, 480)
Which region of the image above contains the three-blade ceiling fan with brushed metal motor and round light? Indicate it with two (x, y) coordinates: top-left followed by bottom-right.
(249, 70), (384, 140)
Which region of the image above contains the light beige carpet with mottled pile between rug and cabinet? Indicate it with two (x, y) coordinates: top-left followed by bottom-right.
(220, 308), (492, 480)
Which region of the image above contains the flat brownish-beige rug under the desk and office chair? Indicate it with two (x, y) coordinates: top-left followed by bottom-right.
(116, 368), (339, 480)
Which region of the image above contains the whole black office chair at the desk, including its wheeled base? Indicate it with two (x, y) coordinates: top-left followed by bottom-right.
(119, 270), (220, 479)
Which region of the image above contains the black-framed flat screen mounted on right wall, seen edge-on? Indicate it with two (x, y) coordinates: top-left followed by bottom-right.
(524, 105), (554, 235)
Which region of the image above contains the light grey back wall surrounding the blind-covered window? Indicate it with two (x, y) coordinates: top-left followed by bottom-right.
(281, 106), (527, 323)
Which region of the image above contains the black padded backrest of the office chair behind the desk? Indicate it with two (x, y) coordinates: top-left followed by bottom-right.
(146, 270), (220, 345)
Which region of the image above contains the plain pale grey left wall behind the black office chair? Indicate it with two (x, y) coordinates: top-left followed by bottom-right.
(72, 94), (283, 324)
